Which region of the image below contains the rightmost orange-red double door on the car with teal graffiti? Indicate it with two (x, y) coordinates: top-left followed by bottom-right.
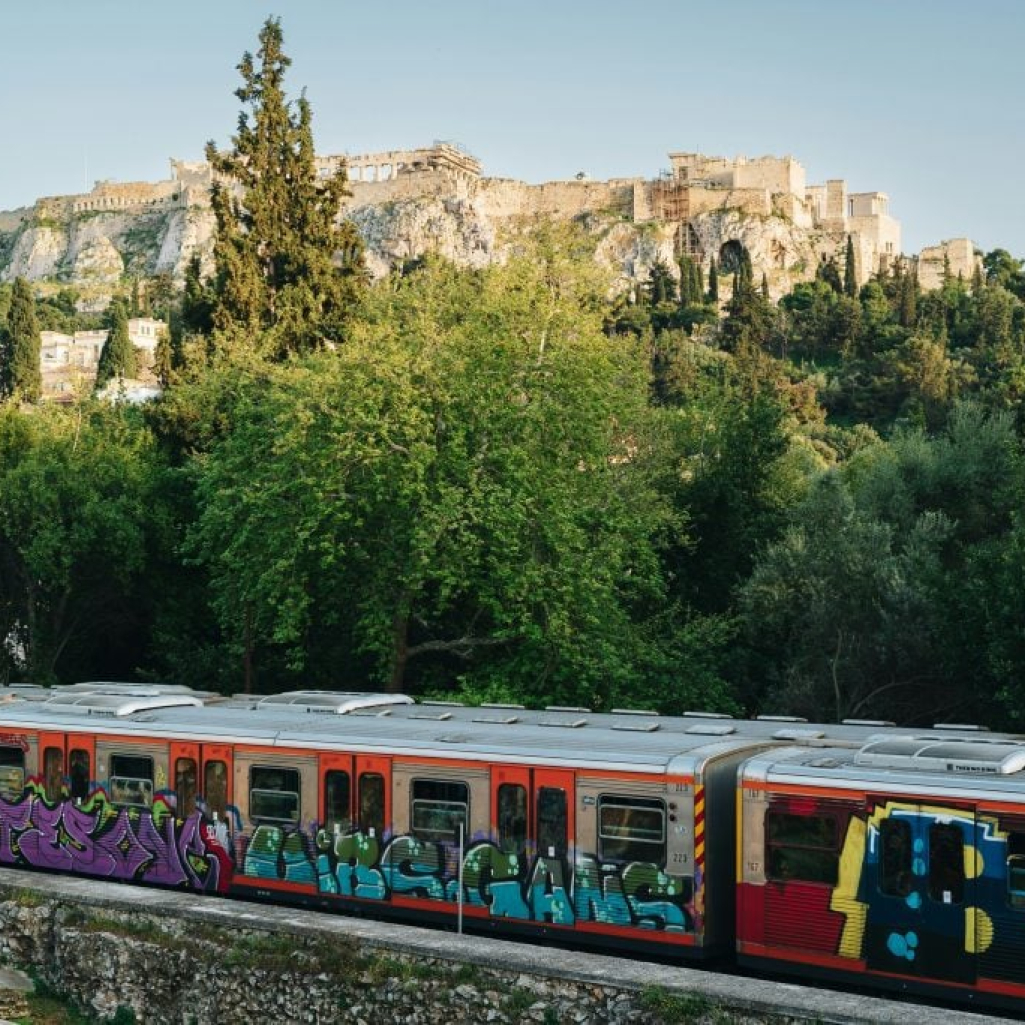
(491, 767), (575, 925)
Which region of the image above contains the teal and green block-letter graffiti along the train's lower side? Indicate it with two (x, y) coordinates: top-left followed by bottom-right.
(242, 825), (699, 933)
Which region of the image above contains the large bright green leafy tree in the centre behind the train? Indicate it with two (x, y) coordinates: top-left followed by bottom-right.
(192, 240), (688, 703)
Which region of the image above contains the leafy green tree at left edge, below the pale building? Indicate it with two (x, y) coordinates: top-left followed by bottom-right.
(0, 404), (161, 684)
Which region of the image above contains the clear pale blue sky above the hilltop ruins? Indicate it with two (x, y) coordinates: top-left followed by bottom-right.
(0, 0), (1025, 257)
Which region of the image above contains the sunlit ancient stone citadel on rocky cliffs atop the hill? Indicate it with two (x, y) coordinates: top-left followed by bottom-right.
(0, 142), (978, 303)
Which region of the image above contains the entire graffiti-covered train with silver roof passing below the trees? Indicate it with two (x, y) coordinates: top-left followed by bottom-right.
(0, 683), (1025, 1010)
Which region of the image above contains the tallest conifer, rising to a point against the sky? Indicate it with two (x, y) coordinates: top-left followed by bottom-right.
(206, 17), (365, 357)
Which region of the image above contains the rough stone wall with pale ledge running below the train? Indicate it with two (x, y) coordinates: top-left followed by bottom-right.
(0, 868), (984, 1025)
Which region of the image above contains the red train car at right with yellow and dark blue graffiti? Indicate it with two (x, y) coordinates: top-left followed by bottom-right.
(737, 730), (1025, 1012)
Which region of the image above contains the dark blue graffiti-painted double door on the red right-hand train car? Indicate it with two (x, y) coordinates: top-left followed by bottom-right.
(865, 798), (979, 984)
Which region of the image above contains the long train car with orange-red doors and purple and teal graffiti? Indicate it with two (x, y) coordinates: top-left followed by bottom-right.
(0, 684), (793, 958)
